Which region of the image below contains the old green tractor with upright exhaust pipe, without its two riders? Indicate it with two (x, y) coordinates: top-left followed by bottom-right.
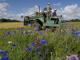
(21, 7), (62, 30)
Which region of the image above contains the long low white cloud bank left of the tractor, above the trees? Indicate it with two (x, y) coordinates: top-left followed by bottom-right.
(0, 5), (41, 21)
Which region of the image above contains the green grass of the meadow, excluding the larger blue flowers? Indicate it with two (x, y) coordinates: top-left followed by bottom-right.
(0, 25), (80, 60)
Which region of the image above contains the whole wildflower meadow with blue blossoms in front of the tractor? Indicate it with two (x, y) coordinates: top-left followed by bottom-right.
(0, 23), (80, 60)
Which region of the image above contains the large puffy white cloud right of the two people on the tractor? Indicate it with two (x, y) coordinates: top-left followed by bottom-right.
(57, 4), (80, 20)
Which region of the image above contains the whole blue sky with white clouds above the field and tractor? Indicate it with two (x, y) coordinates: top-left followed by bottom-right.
(0, 0), (80, 21)
